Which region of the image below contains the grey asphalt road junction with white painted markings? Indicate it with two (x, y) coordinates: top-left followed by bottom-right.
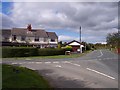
(2, 50), (120, 88)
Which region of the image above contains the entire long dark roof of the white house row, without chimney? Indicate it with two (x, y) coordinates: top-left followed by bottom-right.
(0, 28), (58, 39)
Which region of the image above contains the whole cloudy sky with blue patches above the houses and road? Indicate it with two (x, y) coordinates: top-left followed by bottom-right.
(0, 2), (118, 43)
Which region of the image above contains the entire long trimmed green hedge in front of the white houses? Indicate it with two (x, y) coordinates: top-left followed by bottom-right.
(2, 47), (66, 58)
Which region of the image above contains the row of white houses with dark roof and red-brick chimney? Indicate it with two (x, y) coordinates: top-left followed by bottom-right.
(2, 25), (58, 48)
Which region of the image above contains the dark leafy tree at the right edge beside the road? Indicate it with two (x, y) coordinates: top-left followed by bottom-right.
(106, 32), (120, 47)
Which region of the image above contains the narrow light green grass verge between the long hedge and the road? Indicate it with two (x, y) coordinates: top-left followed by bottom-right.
(3, 51), (91, 60)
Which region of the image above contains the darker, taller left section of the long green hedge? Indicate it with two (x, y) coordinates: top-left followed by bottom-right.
(2, 47), (38, 58)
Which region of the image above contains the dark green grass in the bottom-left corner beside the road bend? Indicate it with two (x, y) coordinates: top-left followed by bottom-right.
(2, 64), (50, 90)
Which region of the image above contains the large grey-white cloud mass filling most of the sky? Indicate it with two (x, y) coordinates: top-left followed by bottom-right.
(4, 2), (118, 40)
